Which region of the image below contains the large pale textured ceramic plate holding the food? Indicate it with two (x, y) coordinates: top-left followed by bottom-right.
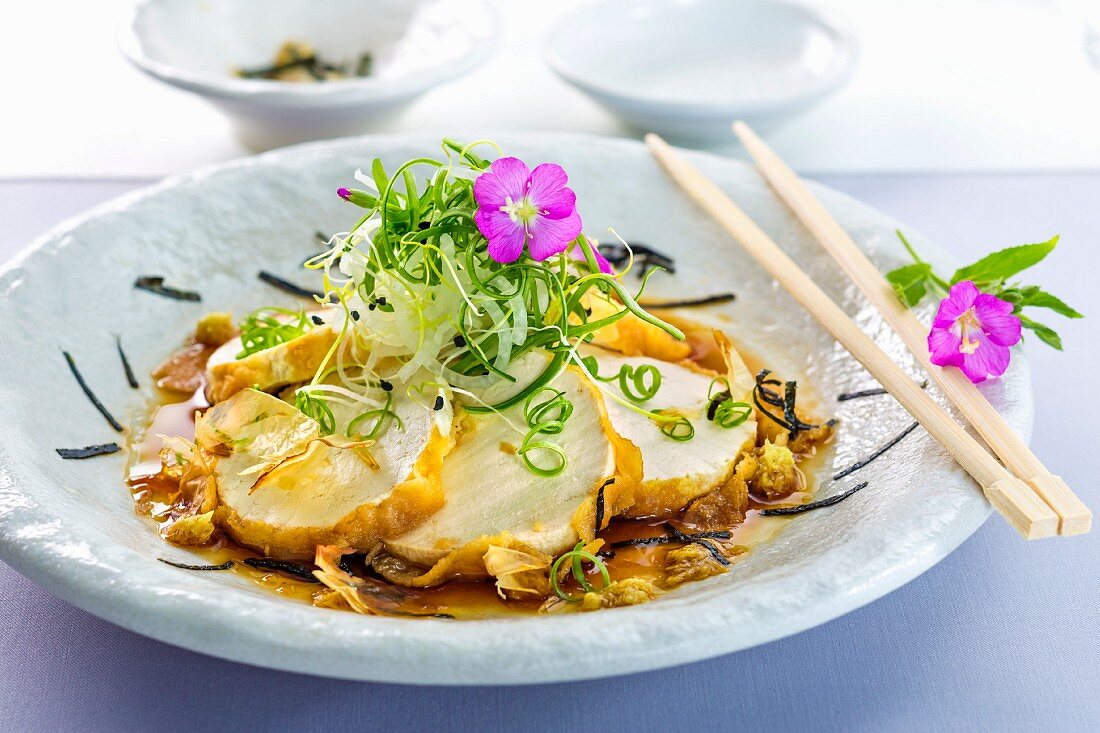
(0, 135), (1032, 683)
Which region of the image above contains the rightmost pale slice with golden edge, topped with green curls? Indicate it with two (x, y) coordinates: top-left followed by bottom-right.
(581, 332), (757, 516)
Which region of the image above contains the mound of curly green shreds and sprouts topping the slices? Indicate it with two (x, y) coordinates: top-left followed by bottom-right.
(297, 140), (683, 475)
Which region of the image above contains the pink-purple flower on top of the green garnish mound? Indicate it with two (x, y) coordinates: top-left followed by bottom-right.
(474, 157), (581, 263)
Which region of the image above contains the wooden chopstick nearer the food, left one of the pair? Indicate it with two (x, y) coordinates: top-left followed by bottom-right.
(646, 133), (1058, 539)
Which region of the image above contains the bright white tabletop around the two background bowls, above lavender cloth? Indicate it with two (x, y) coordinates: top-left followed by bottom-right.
(0, 0), (1100, 176)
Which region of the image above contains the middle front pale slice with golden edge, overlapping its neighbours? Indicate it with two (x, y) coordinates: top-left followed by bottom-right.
(386, 350), (640, 586)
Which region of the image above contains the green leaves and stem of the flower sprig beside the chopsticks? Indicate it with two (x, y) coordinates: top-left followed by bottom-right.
(887, 231), (1082, 350)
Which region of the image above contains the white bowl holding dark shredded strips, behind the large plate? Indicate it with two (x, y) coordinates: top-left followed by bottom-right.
(119, 0), (499, 150)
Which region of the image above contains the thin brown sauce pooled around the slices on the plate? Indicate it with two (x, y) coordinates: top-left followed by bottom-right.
(128, 318), (823, 619)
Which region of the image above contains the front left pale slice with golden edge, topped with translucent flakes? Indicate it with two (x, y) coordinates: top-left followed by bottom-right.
(196, 378), (452, 559)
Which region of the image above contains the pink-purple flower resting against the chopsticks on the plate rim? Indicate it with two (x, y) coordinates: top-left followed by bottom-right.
(928, 280), (1020, 384)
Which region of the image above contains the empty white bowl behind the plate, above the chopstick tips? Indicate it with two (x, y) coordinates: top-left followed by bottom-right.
(546, 0), (858, 140)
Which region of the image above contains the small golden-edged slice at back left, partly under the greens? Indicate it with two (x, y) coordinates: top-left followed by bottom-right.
(207, 310), (339, 404)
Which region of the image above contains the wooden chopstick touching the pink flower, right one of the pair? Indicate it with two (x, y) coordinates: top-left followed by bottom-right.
(734, 117), (1092, 535)
